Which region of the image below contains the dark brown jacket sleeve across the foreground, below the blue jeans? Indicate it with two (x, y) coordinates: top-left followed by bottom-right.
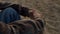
(0, 19), (44, 34)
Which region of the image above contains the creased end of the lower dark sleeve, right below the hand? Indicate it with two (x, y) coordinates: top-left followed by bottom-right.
(35, 18), (45, 34)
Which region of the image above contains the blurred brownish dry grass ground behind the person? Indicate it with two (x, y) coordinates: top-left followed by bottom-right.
(0, 0), (60, 34)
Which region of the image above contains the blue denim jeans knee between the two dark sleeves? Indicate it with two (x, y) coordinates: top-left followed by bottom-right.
(0, 7), (21, 24)
